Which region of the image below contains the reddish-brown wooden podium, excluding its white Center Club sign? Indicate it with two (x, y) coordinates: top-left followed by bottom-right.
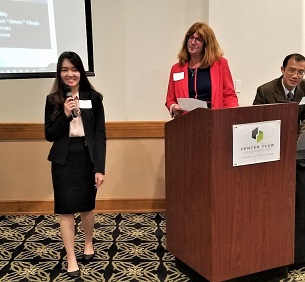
(165, 103), (298, 282)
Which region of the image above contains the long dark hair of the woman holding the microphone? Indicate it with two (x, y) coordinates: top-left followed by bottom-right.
(50, 51), (96, 118)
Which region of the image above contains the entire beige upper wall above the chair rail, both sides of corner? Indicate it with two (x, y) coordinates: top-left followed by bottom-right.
(0, 0), (305, 122)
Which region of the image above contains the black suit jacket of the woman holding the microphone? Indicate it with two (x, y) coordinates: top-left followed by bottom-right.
(45, 91), (106, 174)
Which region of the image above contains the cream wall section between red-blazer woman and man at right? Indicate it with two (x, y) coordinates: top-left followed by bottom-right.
(209, 0), (305, 106)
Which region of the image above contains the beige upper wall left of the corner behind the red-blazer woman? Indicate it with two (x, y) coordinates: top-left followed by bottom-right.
(0, 0), (208, 122)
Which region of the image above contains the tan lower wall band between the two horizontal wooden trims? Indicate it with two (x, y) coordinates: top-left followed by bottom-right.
(0, 138), (165, 201)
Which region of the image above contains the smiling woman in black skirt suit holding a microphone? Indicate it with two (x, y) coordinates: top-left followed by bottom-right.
(45, 52), (106, 277)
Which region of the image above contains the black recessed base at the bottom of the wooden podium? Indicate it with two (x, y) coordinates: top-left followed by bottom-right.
(175, 258), (288, 282)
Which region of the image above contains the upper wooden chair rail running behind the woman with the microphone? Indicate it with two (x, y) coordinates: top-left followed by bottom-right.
(0, 121), (165, 141)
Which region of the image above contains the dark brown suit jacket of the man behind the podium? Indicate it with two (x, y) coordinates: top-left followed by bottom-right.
(253, 77), (305, 120)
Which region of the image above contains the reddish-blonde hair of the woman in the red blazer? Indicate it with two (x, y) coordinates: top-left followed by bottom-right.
(178, 22), (223, 68)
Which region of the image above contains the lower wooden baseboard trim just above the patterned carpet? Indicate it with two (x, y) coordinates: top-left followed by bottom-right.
(0, 199), (165, 215)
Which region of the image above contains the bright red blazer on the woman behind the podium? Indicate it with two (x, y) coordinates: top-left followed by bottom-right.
(165, 57), (238, 110)
